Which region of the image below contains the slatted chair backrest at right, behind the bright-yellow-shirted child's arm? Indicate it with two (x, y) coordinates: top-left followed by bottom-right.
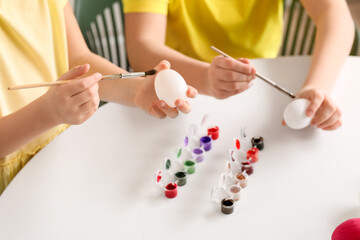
(279, 0), (360, 56)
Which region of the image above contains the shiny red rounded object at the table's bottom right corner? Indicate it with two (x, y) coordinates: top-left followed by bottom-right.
(331, 218), (360, 240)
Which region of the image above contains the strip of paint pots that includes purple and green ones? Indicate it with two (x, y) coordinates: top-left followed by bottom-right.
(156, 115), (219, 198)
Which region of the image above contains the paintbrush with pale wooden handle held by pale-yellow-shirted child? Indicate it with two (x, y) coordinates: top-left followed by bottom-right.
(8, 69), (156, 90)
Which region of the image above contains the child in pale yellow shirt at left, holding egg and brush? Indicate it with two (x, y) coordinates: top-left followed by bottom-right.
(0, 0), (196, 194)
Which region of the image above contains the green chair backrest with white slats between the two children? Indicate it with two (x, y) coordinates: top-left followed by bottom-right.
(74, 0), (129, 70)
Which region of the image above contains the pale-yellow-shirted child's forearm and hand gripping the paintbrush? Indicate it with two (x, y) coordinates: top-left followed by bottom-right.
(0, 65), (101, 158)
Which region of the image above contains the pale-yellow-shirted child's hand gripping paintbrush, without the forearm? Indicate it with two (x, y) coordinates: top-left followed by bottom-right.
(41, 64), (102, 124)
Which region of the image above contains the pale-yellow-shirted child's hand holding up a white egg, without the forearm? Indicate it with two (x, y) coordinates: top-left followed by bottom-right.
(134, 61), (197, 118)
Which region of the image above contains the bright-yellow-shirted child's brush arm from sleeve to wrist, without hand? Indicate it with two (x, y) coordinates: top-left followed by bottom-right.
(125, 13), (210, 94)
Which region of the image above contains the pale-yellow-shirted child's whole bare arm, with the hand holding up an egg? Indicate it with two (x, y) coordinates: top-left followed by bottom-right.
(64, 4), (196, 118)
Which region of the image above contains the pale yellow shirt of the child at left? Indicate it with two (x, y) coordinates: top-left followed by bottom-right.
(0, 0), (68, 194)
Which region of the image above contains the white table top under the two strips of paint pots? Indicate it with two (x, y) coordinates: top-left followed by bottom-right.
(0, 57), (360, 240)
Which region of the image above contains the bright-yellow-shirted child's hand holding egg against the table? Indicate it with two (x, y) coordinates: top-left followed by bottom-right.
(283, 88), (342, 130)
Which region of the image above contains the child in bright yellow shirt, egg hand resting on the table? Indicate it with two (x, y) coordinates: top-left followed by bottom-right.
(123, 0), (354, 130)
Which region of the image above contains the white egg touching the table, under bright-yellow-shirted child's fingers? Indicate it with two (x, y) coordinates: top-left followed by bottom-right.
(284, 98), (311, 129)
